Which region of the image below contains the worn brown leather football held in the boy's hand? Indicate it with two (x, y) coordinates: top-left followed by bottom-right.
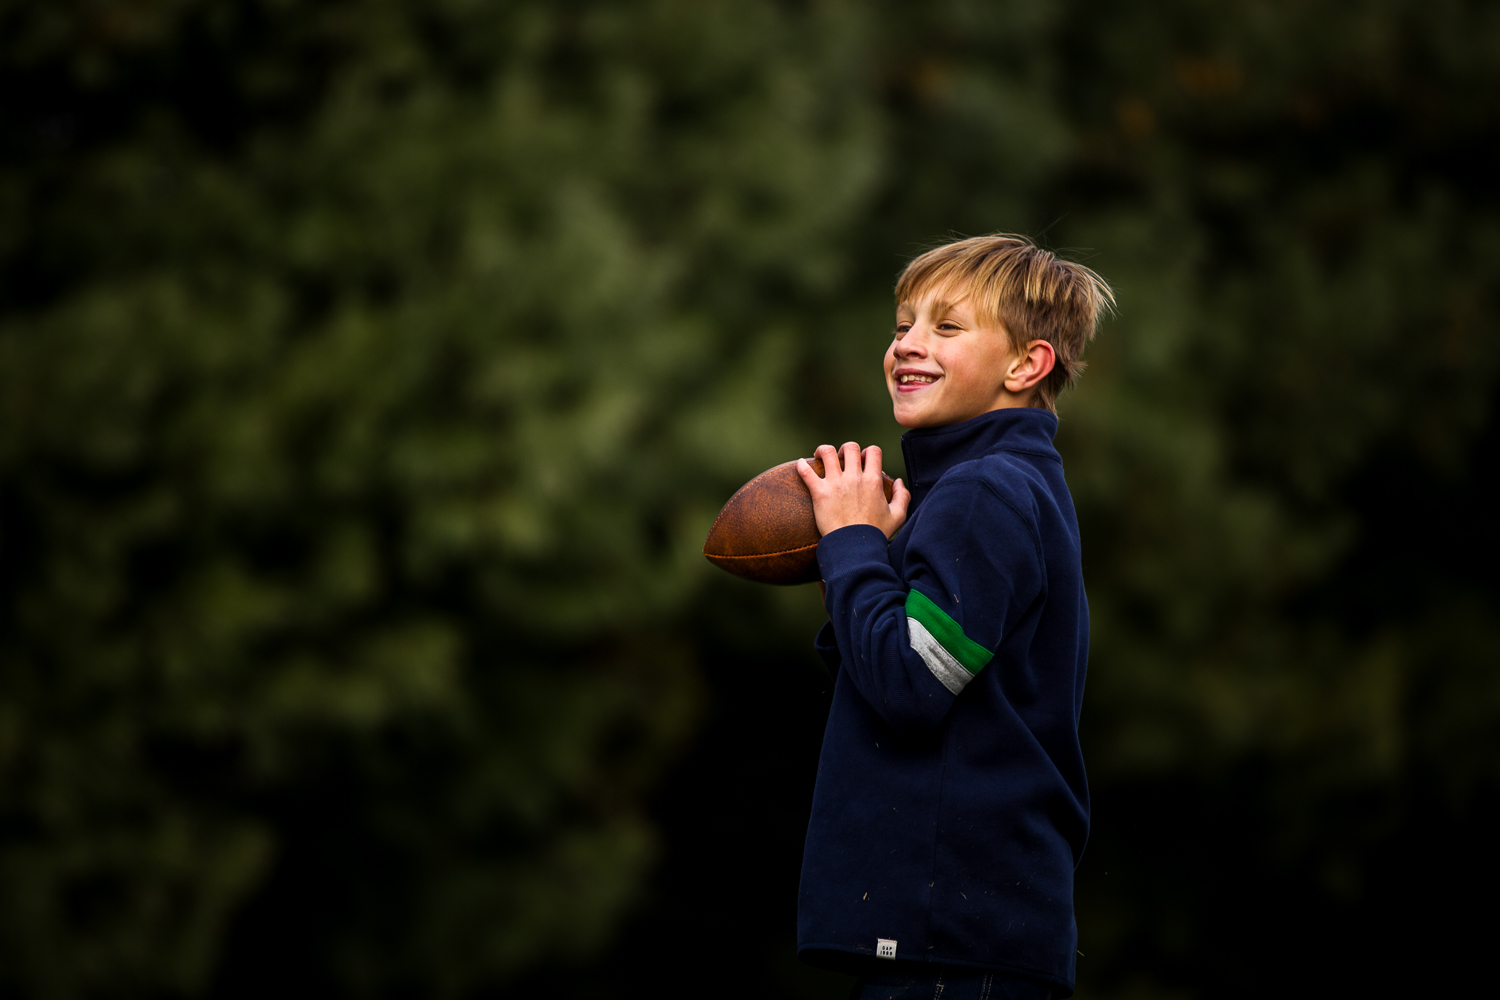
(704, 459), (896, 583)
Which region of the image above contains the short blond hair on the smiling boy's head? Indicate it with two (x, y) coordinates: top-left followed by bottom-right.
(896, 232), (1115, 409)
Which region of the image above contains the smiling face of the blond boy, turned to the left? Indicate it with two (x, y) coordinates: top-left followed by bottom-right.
(885, 289), (1025, 427)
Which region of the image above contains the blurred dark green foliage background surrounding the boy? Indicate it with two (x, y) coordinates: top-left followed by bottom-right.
(0, 0), (1500, 1000)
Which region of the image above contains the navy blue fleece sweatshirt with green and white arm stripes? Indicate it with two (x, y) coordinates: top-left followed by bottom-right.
(798, 408), (1089, 996)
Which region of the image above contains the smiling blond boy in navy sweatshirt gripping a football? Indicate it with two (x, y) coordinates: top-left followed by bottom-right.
(798, 235), (1113, 1000)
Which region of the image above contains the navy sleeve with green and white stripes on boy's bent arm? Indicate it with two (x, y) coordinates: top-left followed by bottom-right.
(818, 481), (1044, 730)
